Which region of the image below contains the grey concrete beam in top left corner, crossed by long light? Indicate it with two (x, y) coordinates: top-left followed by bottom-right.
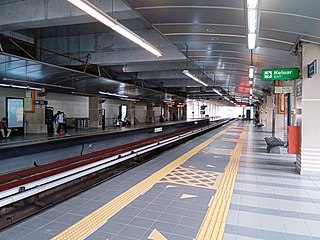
(0, 0), (139, 32)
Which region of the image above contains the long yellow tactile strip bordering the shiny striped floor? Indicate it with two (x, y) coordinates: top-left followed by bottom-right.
(196, 125), (247, 240)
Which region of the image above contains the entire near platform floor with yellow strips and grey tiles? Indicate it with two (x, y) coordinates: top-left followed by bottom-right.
(0, 121), (320, 240)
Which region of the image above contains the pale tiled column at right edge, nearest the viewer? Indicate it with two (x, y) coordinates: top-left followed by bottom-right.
(296, 43), (320, 175)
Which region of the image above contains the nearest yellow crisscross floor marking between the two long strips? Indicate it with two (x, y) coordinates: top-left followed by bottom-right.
(160, 166), (222, 189)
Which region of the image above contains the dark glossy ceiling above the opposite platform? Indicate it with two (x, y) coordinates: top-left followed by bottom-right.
(0, 54), (183, 104)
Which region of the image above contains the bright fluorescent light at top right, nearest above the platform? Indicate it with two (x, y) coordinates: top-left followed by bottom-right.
(246, 0), (260, 49)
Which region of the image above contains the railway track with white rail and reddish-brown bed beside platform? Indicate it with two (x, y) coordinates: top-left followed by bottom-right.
(0, 120), (229, 230)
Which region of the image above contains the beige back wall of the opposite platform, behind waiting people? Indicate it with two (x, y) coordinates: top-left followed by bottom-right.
(0, 88), (168, 129)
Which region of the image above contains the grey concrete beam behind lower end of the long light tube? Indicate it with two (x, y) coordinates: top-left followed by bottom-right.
(38, 29), (185, 66)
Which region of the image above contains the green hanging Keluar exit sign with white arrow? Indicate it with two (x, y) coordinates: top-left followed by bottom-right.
(261, 68), (300, 81)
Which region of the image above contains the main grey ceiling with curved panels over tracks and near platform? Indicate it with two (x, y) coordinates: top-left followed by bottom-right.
(0, 0), (320, 102)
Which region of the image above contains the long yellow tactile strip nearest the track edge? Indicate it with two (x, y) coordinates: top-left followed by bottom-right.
(52, 126), (231, 240)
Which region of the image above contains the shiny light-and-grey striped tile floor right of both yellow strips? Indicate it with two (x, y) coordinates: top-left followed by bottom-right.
(223, 124), (320, 240)
